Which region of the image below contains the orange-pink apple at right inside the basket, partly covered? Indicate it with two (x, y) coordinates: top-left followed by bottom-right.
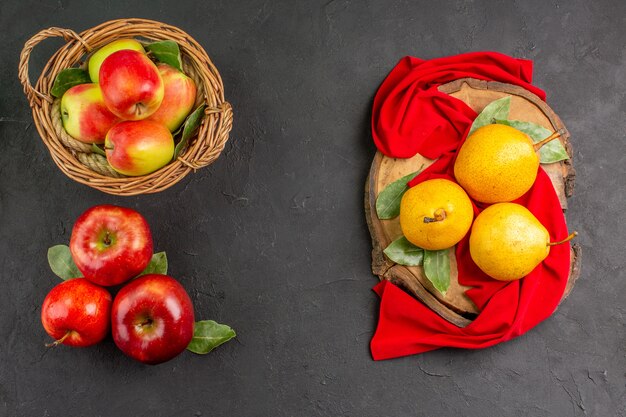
(149, 64), (196, 132)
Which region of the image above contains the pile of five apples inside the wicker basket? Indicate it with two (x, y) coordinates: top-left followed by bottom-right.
(61, 39), (196, 176)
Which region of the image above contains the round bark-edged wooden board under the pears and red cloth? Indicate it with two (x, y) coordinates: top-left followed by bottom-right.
(365, 78), (581, 327)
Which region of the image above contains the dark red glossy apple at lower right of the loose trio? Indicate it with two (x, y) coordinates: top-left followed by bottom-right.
(111, 274), (194, 365)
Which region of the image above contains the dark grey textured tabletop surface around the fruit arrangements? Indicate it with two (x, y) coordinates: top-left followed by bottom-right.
(0, 0), (626, 417)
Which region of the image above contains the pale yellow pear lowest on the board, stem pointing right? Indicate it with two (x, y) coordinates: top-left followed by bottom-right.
(469, 203), (576, 281)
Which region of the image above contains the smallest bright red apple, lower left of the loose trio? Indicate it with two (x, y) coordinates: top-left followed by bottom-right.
(41, 278), (112, 347)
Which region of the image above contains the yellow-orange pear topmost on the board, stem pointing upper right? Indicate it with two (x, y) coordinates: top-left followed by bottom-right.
(454, 124), (560, 203)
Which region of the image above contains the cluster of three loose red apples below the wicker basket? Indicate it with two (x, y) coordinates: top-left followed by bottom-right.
(41, 205), (194, 364)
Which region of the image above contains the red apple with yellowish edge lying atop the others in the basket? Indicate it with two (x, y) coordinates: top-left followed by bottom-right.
(99, 49), (165, 120)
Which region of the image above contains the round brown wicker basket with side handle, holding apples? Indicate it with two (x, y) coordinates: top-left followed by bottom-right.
(19, 19), (233, 196)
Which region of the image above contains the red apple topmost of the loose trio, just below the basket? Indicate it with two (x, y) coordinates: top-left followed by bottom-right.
(70, 205), (152, 286)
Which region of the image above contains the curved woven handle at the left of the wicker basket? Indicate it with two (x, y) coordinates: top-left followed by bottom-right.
(18, 27), (91, 107)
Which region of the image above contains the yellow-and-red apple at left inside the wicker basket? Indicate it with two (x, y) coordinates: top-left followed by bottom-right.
(61, 84), (121, 143)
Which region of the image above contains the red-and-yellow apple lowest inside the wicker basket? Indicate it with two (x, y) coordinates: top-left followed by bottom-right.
(104, 120), (174, 176)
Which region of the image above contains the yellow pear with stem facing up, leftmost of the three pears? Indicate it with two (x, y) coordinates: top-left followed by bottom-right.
(400, 178), (474, 250)
